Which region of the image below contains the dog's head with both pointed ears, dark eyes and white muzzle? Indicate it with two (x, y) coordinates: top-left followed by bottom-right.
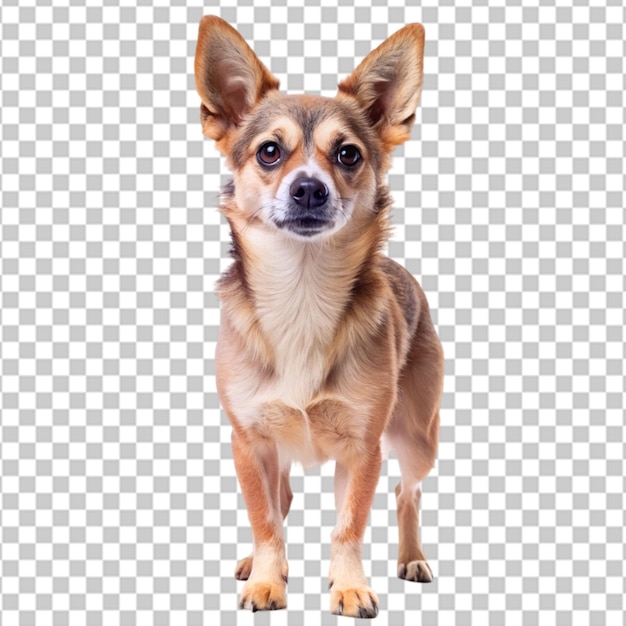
(195, 16), (424, 240)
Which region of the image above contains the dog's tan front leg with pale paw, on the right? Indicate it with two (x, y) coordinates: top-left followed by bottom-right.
(328, 447), (381, 617)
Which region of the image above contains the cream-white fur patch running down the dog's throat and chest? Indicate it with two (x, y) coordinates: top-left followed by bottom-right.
(225, 229), (353, 425)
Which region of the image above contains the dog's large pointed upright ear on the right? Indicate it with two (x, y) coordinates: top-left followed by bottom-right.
(339, 24), (424, 147)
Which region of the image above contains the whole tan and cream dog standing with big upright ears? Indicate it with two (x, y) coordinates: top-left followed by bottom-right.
(195, 16), (444, 617)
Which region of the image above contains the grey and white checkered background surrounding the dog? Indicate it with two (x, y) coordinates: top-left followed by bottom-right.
(0, 0), (626, 626)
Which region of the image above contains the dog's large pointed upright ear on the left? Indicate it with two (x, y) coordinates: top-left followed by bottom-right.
(194, 15), (278, 141)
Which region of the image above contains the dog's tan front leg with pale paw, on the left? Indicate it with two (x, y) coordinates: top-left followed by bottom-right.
(232, 432), (288, 611)
